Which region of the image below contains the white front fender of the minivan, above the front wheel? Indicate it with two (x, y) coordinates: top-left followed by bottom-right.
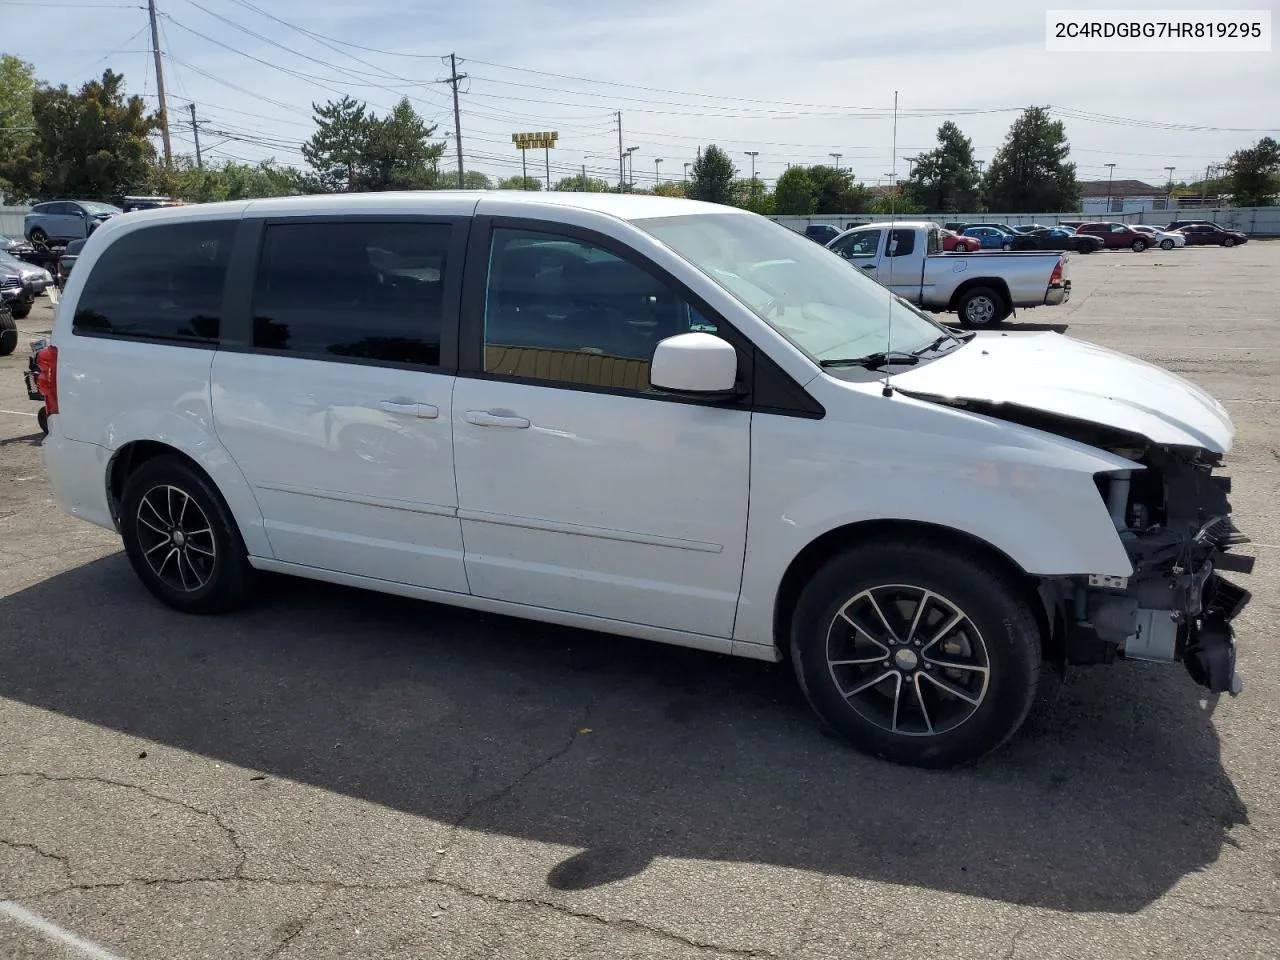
(733, 387), (1139, 644)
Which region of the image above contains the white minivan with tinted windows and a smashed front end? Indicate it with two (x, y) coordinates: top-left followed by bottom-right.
(38, 192), (1253, 767)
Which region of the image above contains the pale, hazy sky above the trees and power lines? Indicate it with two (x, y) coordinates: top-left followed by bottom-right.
(0, 0), (1280, 186)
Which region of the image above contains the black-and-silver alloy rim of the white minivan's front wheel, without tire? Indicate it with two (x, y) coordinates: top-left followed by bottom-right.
(826, 584), (991, 737)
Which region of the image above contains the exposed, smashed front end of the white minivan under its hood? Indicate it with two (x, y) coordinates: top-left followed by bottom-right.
(931, 398), (1253, 695)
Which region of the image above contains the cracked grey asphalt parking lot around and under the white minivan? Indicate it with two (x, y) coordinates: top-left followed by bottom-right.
(0, 242), (1280, 960)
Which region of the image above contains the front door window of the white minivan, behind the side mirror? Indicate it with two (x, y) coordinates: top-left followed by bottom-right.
(484, 229), (718, 390)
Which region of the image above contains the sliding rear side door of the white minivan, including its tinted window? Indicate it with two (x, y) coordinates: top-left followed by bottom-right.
(212, 219), (467, 593)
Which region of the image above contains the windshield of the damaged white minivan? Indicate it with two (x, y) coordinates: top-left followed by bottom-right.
(634, 214), (951, 362)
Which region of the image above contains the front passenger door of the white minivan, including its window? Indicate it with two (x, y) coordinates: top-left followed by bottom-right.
(453, 221), (751, 637)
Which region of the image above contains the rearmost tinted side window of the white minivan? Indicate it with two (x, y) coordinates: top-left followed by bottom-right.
(73, 220), (236, 342)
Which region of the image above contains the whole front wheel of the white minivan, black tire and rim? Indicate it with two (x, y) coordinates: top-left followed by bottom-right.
(791, 539), (1041, 768)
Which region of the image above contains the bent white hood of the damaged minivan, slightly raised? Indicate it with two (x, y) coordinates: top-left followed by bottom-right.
(893, 333), (1235, 453)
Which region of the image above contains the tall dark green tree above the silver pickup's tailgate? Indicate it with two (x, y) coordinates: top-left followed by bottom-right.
(983, 106), (1080, 214)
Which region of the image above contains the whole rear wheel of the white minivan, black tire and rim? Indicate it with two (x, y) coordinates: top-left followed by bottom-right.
(120, 456), (252, 613)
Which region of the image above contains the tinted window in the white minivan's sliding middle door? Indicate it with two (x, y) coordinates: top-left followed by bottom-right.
(253, 221), (452, 366)
